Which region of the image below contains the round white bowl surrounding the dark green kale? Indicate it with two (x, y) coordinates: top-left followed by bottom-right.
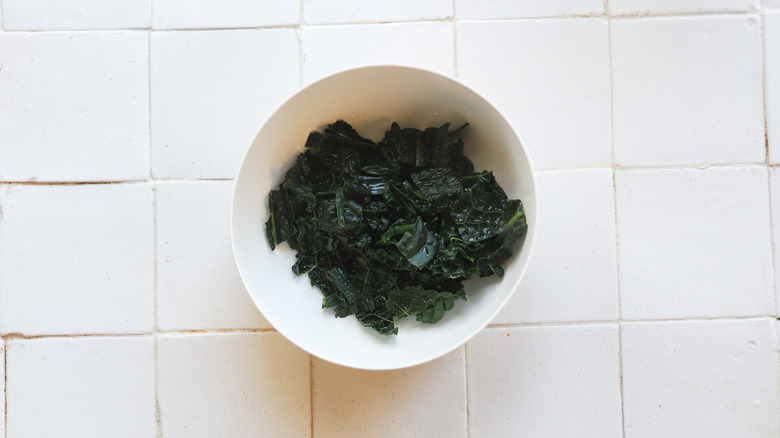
(231, 65), (537, 370)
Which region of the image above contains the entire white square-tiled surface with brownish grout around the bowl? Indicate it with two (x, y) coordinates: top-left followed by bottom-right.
(0, 0), (780, 438)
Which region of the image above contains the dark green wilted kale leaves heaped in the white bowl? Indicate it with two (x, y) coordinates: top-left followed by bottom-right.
(265, 120), (527, 334)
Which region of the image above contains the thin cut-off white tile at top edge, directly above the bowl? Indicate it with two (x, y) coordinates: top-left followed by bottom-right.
(302, 0), (452, 24)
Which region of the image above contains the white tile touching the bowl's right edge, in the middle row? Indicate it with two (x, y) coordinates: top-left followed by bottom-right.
(493, 169), (618, 324)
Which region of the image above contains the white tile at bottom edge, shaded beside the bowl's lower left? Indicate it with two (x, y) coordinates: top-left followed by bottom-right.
(157, 332), (311, 438)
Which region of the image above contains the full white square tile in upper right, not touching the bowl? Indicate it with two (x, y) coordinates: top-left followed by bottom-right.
(612, 15), (765, 166)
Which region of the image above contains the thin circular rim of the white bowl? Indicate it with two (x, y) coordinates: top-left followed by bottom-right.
(229, 63), (540, 371)
